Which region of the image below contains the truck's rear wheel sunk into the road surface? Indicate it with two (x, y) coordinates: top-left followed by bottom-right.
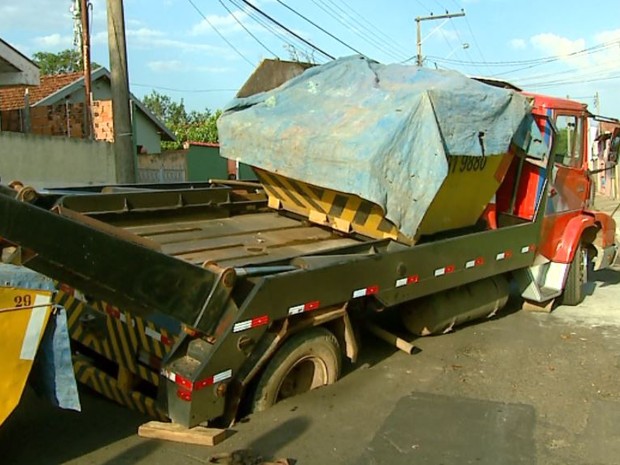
(252, 328), (342, 412)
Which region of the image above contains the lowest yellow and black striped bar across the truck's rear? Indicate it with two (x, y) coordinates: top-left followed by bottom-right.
(73, 358), (166, 420)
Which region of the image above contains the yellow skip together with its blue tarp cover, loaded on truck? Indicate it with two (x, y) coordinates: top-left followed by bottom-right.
(218, 56), (543, 244)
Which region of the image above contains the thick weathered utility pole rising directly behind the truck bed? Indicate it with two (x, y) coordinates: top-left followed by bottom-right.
(107, 0), (136, 184)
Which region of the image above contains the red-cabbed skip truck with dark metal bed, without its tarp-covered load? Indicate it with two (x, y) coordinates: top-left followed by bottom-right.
(0, 88), (616, 427)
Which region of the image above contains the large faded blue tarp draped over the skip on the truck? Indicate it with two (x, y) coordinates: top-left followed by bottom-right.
(218, 56), (546, 236)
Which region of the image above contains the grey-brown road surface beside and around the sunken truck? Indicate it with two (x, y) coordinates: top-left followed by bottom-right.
(0, 268), (620, 465)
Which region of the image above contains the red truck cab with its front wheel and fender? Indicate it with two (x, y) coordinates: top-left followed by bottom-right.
(497, 93), (617, 305)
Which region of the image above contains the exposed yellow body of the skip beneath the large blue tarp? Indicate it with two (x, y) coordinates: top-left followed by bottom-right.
(255, 152), (513, 244)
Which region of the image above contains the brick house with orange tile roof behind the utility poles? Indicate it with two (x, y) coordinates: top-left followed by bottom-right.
(0, 68), (175, 154)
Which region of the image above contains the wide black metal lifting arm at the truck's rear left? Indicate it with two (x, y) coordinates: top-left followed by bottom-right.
(0, 189), (220, 324)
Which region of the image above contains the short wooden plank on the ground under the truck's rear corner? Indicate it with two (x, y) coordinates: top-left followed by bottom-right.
(138, 421), (227, 446)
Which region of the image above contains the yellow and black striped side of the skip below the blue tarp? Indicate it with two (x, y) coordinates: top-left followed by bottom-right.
(256, 170), (413, 244)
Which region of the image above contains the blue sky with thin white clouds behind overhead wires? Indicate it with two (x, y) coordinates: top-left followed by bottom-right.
(0, 0), (620, 117)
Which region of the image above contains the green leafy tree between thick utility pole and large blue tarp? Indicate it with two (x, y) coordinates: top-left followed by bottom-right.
(142, 91), (222, 150)
